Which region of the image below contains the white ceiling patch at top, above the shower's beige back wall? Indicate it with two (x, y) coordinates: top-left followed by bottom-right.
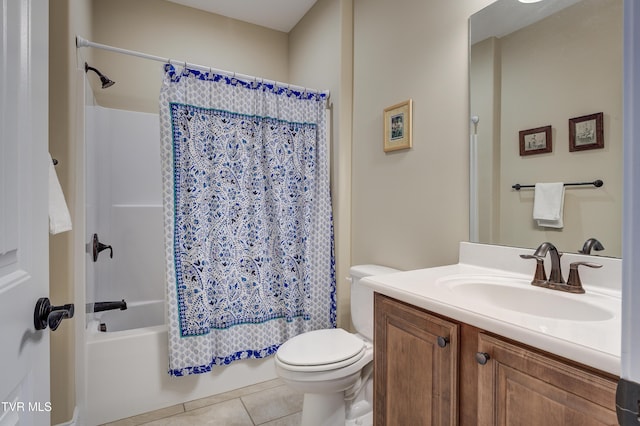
(164, 0), (316, 33)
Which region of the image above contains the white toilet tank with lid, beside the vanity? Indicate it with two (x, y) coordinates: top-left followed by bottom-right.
(349, 265), (400, 341)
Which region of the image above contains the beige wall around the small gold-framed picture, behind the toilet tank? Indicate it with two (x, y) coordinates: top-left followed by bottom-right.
(352, 0), (491, 269)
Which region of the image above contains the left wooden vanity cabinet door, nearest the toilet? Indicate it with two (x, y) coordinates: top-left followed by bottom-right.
(374, 294), (458, 426)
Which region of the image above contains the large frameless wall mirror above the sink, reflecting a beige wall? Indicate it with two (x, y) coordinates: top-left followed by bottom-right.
(469, 0), (623, 257)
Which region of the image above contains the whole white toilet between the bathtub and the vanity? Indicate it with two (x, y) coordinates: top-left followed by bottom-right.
(275, 265), (398, 426)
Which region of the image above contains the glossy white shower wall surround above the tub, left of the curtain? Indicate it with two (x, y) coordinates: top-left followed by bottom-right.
(84, 107), (165, 333)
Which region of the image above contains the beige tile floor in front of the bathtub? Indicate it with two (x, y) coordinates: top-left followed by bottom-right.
(105, 379), (302, 426)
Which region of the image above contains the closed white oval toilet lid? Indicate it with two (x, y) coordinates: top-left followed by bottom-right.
(276, 328), (365, 366)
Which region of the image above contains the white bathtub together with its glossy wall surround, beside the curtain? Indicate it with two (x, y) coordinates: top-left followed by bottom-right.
(85, 107), (276, 426)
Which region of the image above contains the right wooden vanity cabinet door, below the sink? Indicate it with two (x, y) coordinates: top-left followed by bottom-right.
(478, 333), (618, 426)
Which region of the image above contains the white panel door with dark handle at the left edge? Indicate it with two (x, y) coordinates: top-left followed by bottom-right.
(0, 0), (52, 426)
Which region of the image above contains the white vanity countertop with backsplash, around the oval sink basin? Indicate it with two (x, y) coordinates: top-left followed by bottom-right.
(362, 243), (621, 376)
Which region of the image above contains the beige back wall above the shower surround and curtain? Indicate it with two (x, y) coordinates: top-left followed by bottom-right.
(89, 0), (288, 113)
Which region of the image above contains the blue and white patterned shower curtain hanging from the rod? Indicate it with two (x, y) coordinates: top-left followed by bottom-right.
(160, 65), (336, 376)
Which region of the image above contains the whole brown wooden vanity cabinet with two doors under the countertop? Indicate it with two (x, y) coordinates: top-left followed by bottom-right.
(374, 293), (617, 426)
